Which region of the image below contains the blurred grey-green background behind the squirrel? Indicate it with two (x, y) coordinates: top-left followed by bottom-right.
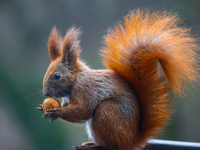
(0, 0), (200, 150)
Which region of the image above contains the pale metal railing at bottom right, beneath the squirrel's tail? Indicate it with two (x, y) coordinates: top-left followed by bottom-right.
(143, 140), (200, 150)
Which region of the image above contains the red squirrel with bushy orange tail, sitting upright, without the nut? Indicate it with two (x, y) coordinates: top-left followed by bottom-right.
(40, 9), (198, 150)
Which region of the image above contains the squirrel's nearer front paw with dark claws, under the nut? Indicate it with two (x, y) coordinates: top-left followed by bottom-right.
(43, 108), (60, 122)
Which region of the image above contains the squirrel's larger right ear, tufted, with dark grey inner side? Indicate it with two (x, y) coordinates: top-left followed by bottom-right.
(61, 27), (81, 66)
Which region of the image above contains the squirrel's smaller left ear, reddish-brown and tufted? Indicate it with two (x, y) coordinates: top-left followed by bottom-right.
(47, 27), (62, 61)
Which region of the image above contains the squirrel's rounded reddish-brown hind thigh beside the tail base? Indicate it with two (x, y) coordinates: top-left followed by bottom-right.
(92, 97), (139, 150)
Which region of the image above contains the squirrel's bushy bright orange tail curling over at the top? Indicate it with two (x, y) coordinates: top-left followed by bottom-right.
(102, 10), (197, 146)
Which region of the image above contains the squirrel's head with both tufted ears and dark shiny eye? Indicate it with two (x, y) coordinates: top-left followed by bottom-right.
(43, 27), (81, 97)
